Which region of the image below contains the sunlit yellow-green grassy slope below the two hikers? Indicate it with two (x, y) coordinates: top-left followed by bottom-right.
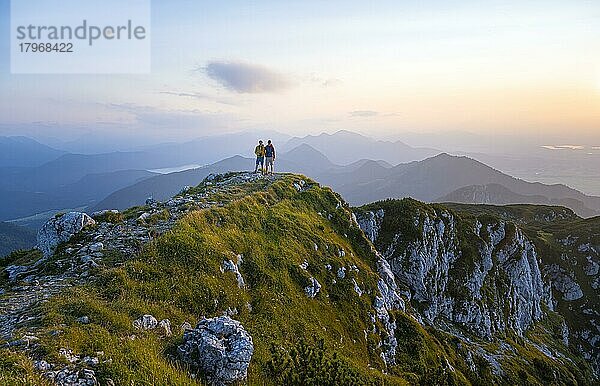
(1, 176), (403, 385)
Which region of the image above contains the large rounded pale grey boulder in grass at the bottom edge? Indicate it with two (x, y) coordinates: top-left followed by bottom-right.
(178, 316), (254, 385)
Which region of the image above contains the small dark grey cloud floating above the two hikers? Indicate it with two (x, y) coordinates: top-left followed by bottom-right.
(203, 61), (292, 94)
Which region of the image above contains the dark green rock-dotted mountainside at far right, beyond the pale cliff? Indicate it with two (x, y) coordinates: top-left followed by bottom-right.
(446, 205), (600, 375)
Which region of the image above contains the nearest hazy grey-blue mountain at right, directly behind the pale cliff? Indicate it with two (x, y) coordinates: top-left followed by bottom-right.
(317, 153), (600, 216)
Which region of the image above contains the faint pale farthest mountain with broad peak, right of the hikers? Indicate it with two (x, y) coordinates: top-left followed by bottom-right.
(284, 130), (440, 165)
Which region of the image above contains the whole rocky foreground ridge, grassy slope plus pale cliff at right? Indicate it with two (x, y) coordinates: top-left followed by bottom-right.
(0, 173), (600, 385)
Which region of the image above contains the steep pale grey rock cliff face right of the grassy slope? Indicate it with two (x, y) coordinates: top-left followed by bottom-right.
(358, 210), (552, 339)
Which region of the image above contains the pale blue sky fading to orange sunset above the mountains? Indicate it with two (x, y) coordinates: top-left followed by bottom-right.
(0, 0), (600, 145)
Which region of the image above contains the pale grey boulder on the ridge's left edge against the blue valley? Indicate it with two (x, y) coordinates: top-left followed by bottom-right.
(37, 212), (96, 257)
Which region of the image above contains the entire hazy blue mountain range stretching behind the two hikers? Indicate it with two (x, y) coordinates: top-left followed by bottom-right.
(0, 131), (599, 235)
